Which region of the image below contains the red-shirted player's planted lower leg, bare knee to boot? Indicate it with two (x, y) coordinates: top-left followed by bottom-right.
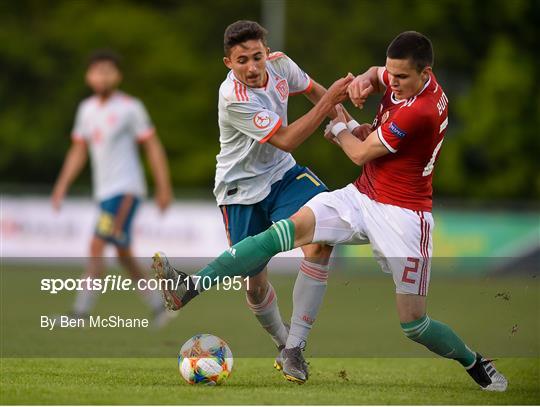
(396, 294), (508, 391)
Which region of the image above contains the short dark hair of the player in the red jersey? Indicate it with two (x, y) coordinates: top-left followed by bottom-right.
(386, 31), (433, 72)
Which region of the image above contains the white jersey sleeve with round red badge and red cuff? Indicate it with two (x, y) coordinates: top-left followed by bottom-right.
(227, 102), (282, 143)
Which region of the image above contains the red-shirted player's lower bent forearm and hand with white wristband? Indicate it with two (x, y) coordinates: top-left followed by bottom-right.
(325, 106), (389, 165)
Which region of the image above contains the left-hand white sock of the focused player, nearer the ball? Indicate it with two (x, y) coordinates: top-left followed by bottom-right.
(246, 283), (287, 347)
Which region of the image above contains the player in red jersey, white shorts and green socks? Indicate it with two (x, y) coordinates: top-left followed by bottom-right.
(155, 31), (508, 391)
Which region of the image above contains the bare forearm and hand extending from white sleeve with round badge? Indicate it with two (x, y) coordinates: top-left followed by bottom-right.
(268, 74), (354, 152)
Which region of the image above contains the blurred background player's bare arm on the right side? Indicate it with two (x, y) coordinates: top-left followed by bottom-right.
(143, 134), (172, 211)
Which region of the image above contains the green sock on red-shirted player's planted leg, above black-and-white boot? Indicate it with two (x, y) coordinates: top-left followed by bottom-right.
(401, 315), (476, 368)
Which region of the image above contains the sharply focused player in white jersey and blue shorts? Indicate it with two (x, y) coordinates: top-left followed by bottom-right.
(154, 21), (352, 376)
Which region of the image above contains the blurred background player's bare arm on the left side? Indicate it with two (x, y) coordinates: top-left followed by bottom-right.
(51, 140), (88, 210)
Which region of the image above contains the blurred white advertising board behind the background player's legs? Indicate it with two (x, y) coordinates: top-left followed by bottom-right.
(0, 196), (301, 262)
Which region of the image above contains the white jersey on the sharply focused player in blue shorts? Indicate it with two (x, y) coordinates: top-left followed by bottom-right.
(214, 52), (312, 205)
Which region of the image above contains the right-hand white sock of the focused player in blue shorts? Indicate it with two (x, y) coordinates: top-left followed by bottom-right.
(285, 259), (329, 348)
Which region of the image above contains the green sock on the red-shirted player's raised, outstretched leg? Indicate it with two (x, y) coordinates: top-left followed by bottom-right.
(195, 219), (294, 291)
